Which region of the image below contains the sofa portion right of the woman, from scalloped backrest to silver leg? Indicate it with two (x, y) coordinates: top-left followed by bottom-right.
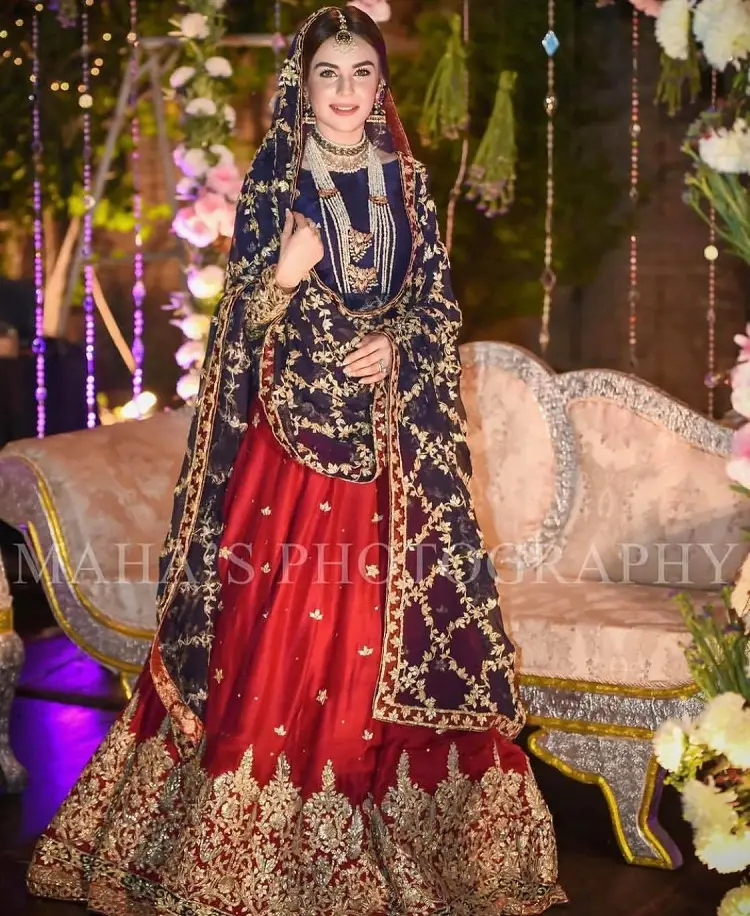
(462, 343), (750, 868)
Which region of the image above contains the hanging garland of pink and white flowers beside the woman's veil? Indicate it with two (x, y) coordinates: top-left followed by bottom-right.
(169, 0), (242, 401)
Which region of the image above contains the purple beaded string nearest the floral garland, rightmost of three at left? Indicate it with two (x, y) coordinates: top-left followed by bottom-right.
(128, 0), (146, 398)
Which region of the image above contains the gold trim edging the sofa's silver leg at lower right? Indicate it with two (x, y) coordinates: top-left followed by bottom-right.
(528, 728), (681, 870)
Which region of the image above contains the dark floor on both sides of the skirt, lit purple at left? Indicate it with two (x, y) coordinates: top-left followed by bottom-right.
(0, 580), (736, 916)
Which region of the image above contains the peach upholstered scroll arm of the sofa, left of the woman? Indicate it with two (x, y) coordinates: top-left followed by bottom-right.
(0, 409), (191, 600)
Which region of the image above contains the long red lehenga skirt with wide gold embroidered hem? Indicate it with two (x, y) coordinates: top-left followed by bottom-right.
(28, 401), (566, 916)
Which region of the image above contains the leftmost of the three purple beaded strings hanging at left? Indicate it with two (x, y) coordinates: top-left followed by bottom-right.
(29, 3), (47, 439)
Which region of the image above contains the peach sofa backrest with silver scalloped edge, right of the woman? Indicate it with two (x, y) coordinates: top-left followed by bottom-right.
(461, 342), (750, 589)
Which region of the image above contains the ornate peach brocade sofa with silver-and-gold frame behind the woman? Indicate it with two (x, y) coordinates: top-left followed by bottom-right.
(0, 343), (750, 868)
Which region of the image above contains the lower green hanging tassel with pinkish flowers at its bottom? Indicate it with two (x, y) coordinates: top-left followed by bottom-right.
(466, 70), (518, 217)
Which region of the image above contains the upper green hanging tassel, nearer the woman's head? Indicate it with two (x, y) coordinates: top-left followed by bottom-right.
(419, 15), (469, 146)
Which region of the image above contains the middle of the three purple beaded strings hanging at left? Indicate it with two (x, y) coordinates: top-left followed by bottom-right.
(79, 0), (96, 429)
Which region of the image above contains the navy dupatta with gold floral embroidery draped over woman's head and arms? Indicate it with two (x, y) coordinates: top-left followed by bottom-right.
(150, 11), (523, 746)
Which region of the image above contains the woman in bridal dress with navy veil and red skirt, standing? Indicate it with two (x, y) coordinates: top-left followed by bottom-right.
(28, 8), (565, 916)
